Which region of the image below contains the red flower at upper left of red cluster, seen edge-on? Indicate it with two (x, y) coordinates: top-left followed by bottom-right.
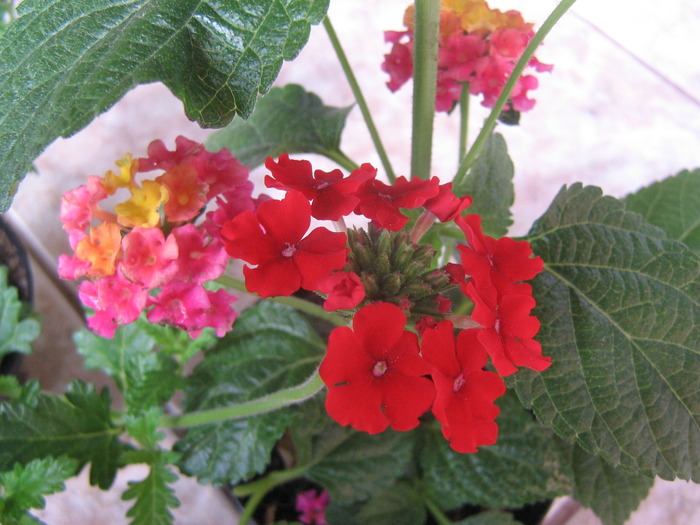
(265, 153), (377, 221)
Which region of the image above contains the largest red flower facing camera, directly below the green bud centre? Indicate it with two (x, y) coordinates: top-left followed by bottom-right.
(319, 303), (435, 434)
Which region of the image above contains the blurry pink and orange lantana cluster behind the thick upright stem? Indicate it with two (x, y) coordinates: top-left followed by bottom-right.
(382, 0), (552, 111)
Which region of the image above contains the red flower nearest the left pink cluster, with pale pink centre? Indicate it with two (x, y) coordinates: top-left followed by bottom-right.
(221, 191), (348, 297)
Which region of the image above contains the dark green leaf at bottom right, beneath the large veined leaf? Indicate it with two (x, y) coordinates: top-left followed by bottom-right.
(570, 445), (654, 525)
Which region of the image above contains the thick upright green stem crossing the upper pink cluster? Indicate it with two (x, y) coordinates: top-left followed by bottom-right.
(411, 0), (440, 179)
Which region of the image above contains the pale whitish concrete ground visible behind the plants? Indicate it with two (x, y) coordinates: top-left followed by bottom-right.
(5, 0), (700, 525)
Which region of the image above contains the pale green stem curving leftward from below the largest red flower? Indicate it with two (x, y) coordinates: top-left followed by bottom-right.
(159, 370), (323, 428)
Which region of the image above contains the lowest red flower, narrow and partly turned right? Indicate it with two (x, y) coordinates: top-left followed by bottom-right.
(421, 321), (505, 452)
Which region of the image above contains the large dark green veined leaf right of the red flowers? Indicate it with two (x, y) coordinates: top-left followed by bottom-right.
(514, 184), (700, 481)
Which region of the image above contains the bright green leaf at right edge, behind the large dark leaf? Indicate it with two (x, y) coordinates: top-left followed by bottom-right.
(624, 169), (700, 251)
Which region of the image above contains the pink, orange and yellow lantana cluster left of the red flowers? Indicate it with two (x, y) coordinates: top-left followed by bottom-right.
(58, 137), (255, 337)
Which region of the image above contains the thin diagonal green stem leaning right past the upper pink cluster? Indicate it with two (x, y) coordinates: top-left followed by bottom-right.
(453, 0), (576, 186)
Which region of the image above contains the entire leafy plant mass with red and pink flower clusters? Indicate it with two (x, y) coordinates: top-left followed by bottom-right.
(0, 0), (700, 525)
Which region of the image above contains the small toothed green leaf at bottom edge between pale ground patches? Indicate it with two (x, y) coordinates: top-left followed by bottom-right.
(122, 463), (180, 525)
